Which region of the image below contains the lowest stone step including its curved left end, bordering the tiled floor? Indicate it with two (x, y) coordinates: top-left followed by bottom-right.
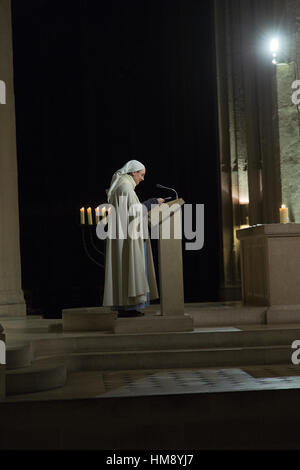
(6, 338), (291, 396)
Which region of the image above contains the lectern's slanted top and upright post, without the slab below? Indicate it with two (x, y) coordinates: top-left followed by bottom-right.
(148, 199), (184, 315)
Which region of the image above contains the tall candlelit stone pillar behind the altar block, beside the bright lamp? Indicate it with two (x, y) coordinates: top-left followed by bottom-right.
(214, 0), (284, 300)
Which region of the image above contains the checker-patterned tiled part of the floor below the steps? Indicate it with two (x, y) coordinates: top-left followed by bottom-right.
(102, 366), (300, 397)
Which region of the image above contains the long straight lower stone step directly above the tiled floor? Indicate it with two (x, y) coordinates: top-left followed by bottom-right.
(29, 345), (293, 372)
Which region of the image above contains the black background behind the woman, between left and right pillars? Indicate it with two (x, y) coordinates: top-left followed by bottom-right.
(12, 0), (220, 316)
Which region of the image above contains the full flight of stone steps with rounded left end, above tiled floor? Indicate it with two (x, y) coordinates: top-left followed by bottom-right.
(1, 312), (300, 396)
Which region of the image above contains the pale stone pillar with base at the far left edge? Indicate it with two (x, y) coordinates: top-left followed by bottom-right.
(0, 0), (26, 316)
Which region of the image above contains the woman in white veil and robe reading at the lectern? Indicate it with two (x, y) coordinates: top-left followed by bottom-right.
(103, 160), (164, 317)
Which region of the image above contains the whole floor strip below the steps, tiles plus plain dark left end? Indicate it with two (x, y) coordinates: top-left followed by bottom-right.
(6, 365), (300, 402)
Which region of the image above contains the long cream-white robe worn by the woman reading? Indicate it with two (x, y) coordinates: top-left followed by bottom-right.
(103, 174), (158, 306)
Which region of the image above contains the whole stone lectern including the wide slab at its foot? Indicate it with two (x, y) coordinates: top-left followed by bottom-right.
(114, 199), (193, 333)
